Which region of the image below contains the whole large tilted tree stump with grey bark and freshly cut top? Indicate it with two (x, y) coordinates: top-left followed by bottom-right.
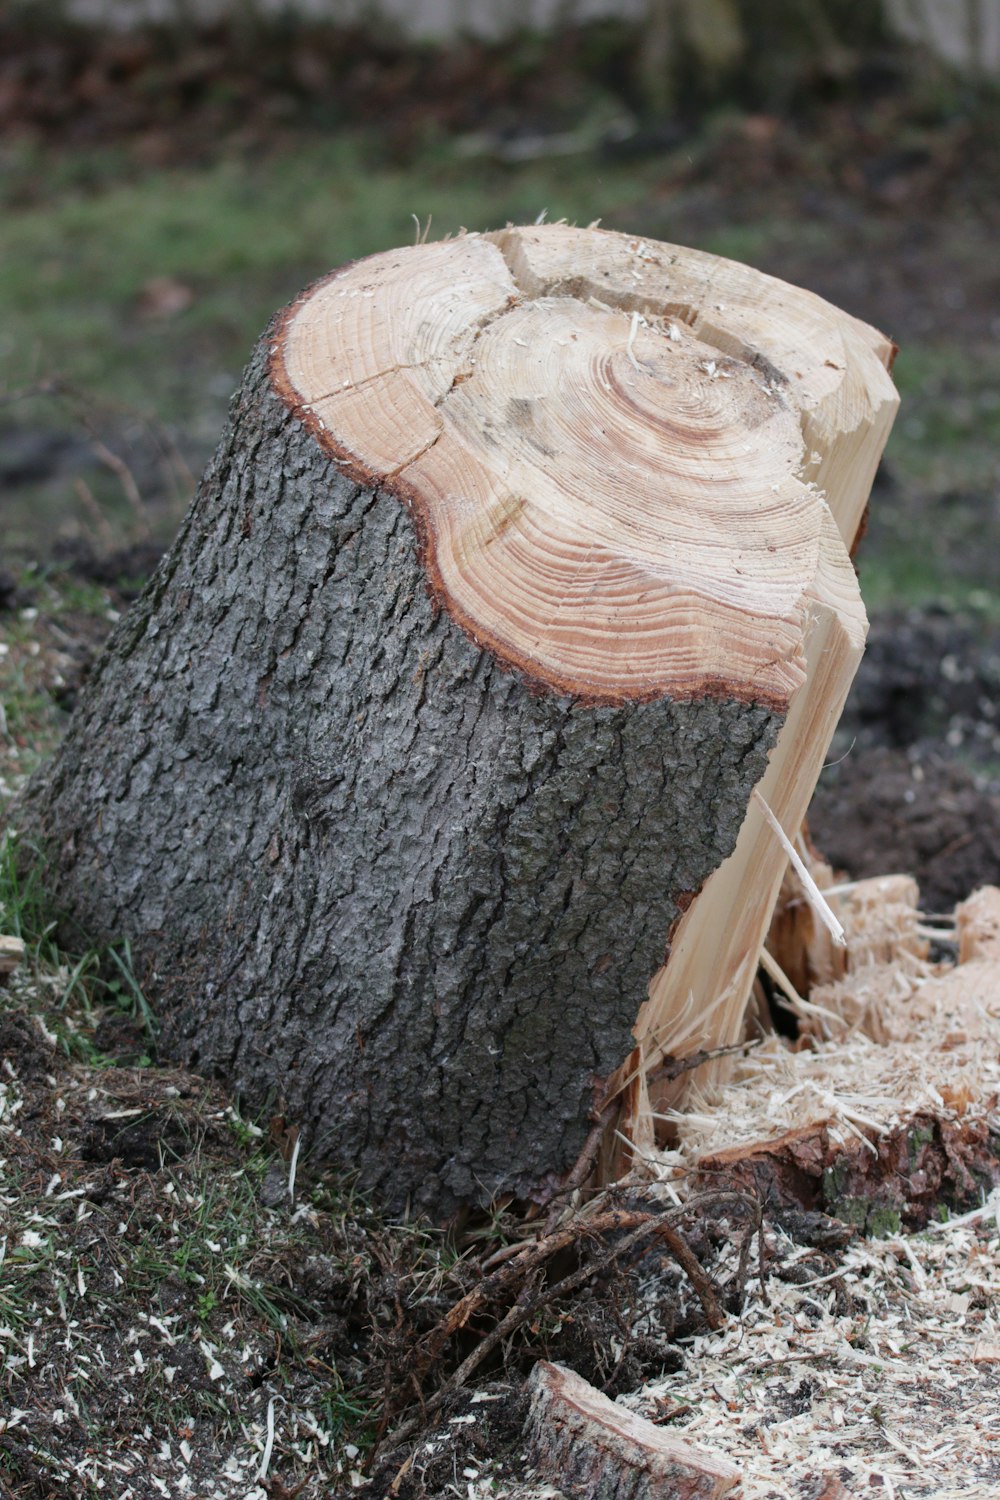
(15, 225), (897, 1217)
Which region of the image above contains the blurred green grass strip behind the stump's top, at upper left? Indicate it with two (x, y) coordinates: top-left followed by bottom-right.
(0, 137), (671, 420)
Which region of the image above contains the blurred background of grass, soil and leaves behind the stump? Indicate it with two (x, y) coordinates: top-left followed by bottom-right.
(0, 0), (1000, 894)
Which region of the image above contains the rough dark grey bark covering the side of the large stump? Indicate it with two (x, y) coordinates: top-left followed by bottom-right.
(15, 316), (780, 1218)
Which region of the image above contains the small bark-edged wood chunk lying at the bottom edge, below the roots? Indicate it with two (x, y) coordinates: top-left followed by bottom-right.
(525, 1361), (739, 1500)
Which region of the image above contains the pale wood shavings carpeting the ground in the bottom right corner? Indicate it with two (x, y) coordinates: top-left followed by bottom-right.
(624, 1196), (1000, 1500)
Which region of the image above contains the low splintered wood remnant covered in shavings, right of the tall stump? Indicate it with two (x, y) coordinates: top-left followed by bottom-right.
(651, 876), (1000, 1229)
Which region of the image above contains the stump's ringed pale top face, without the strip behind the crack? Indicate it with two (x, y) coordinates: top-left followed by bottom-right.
(279, 231), (821, 711)
